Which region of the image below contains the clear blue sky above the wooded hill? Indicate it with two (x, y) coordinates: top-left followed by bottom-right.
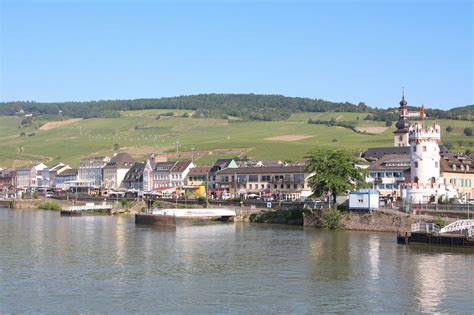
(0, 0), (474, 108)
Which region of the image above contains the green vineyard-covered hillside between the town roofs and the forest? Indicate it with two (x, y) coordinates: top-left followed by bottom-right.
(0, 110), (474, 167)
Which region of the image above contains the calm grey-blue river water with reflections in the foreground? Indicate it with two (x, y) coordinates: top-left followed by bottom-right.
(0, 209), (474, 314)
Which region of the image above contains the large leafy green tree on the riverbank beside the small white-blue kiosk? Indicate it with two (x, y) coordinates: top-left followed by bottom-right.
(306, 149), (366, 203)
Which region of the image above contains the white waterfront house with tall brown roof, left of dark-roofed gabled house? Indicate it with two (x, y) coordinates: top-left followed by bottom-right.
(103, 153), (135, 190)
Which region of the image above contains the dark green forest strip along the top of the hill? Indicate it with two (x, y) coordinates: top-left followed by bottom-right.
(0, 94), (474, 121)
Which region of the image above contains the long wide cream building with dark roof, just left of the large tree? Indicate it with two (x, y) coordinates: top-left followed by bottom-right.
(215, 164), (313, 200)
